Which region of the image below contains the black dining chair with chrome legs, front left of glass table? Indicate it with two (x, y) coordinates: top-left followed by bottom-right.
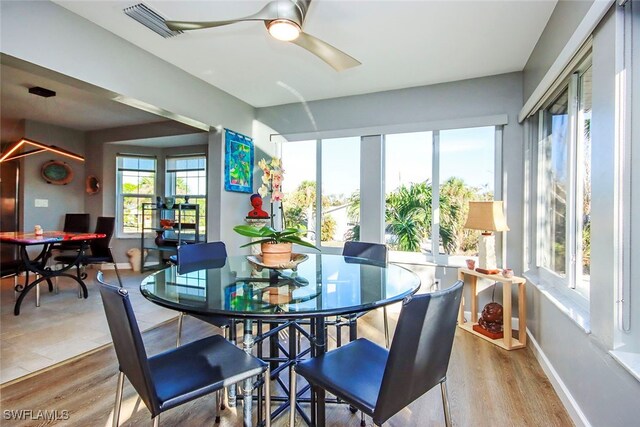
(97, 272), (271, 427)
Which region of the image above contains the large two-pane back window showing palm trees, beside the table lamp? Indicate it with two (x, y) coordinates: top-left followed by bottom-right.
(385, 126), (496, 265)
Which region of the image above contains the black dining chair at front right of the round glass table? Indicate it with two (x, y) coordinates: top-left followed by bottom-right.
(289, 280), (463, 426)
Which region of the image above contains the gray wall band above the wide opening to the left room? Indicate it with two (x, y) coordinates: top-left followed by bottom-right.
(0, 1), (253, 134)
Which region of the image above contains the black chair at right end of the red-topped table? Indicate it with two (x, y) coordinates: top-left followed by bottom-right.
(54, 216), (122, 290)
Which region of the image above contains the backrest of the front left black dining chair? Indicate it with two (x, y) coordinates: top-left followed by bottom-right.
(97, 271), (160, 416)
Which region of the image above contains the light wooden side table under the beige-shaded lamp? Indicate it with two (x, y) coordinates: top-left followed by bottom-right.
(458, 268), (527, 350)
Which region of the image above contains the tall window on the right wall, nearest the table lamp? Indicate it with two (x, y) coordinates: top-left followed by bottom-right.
(535, 59), (591, 299)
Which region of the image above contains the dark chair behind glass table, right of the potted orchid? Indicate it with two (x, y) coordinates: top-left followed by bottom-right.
(336, 242), (389, 348)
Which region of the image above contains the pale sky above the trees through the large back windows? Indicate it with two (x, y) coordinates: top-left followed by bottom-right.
(282, 126), (495, 199)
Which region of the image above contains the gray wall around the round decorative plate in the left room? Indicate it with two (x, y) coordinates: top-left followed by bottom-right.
(20, 120), (85, 231)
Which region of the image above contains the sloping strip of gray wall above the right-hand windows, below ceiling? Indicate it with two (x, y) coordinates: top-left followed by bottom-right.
(523, 0), (593, 101)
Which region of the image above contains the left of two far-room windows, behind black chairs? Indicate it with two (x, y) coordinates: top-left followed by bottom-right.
(116, 155), (156, 237)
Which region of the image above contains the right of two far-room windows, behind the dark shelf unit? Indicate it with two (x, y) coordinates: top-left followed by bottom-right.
(165, 154), (207, 235)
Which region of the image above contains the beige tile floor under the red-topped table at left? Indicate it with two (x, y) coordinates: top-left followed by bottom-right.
(0, 269), (177, 383)
